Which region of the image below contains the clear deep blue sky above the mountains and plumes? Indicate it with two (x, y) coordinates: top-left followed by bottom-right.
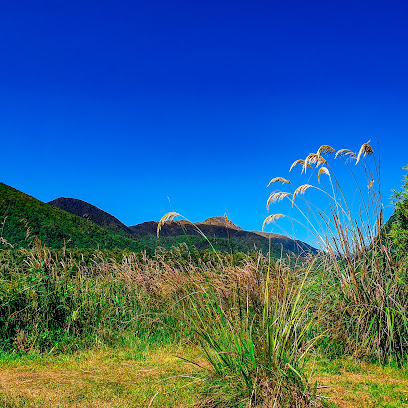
(0, 0), (408, 242)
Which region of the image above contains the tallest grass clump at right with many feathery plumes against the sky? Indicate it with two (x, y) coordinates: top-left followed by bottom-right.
(264, 143), (408, 363)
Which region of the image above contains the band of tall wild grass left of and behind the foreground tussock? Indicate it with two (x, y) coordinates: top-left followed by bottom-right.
(0, 241), (266, 352)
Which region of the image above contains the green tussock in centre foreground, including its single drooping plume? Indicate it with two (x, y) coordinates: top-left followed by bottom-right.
(158, 213), (321, 408)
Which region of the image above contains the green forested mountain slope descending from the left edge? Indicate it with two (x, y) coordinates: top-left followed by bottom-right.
(0, 183), (144, 251)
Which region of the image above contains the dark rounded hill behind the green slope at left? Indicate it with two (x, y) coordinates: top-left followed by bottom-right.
(48, 197), (131, 234)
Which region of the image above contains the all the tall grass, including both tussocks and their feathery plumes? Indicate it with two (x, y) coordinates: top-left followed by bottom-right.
(0, 143), (408, 408)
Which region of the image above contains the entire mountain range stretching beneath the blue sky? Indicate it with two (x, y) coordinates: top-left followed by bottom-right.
(0, 183), (316, 258)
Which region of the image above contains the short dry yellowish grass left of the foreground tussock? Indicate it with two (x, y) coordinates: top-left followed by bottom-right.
(0, 347), (206, 407)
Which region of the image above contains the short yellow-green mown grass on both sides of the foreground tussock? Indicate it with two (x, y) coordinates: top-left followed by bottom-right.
(0, 346), (408, 408)
